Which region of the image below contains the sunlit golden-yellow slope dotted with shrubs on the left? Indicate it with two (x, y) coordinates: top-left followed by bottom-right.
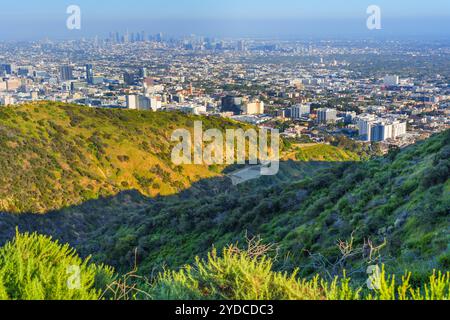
(0, 103), (251, 213)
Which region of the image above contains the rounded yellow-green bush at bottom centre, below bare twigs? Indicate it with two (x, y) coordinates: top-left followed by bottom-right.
(150, 247), (325, 300)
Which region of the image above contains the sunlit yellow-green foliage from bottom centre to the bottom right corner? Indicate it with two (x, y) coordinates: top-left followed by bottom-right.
(149, 247), (450, 300)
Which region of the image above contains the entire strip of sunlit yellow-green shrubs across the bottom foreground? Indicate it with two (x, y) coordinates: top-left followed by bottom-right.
(0, 234), (450, 300)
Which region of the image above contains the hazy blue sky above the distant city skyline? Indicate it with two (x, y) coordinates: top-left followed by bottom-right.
(0, 0), (450, 40)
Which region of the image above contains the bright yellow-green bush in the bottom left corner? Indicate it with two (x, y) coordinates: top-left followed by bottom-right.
(0, 233), (113, 300)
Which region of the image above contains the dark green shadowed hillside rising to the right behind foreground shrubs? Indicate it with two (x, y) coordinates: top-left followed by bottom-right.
(0, 132), (450, 281)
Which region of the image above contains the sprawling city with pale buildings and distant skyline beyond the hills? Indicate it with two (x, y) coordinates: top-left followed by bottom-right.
(0, 32), (450, 150)
